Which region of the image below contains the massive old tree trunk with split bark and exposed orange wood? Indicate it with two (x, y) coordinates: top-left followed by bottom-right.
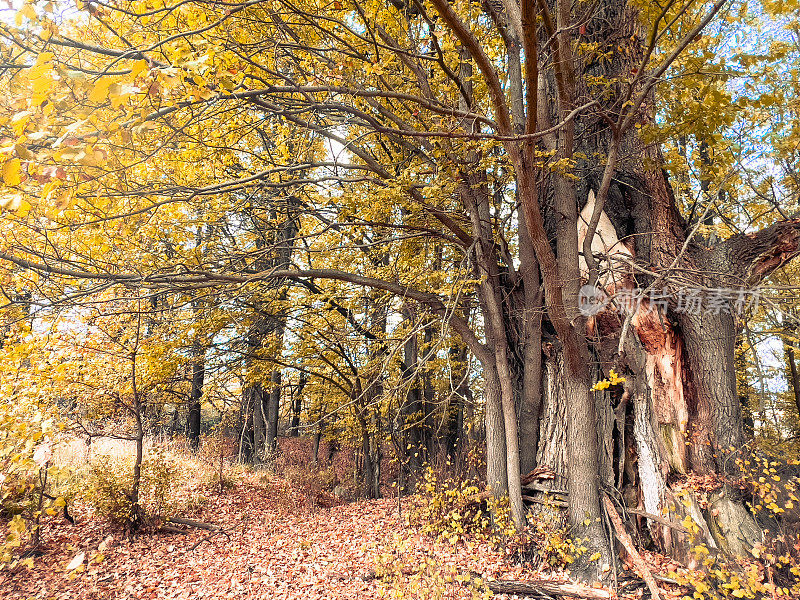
(517, 0), (798, 554)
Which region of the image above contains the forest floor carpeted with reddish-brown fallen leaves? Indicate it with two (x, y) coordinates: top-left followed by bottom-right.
(0, 472), (688, 600)
